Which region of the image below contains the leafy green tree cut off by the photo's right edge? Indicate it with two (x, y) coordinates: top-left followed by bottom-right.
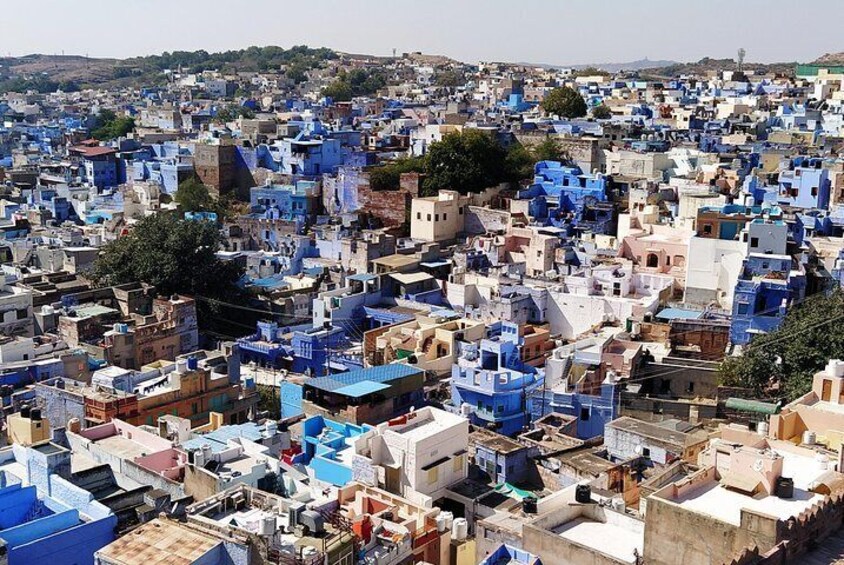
(719, 290), (844, 399)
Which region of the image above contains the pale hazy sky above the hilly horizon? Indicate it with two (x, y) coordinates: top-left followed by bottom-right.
(6, 0), (844, 64)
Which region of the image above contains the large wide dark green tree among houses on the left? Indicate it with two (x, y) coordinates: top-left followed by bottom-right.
(92, 213), (243, 301)
